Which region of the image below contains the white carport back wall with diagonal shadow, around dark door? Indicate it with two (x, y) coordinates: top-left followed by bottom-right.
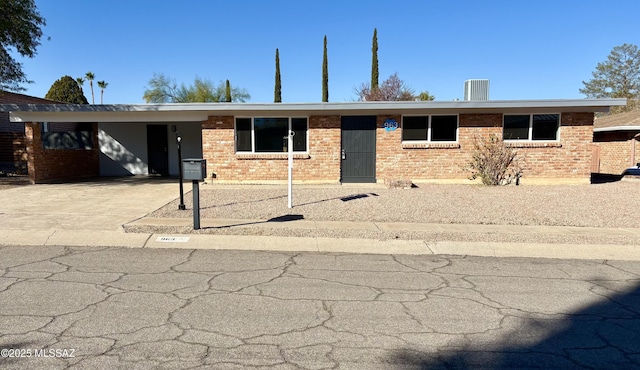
(98, 122), (202, 176)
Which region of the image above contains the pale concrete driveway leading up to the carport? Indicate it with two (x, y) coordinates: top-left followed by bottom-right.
(0, 177), (185, 231)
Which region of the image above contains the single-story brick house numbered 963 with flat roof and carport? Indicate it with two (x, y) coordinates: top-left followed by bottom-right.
(0, 99), (626, 183)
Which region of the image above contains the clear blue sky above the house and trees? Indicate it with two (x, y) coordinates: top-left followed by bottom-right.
(13, 0), (640, 104)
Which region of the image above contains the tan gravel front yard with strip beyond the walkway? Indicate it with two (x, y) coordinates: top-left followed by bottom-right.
(125, 181), (640, 245)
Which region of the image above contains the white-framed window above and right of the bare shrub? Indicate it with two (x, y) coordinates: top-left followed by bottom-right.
(502, 113), (560, 141)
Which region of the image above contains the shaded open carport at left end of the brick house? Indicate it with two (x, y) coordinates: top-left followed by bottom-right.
(2, 104), (208, 184)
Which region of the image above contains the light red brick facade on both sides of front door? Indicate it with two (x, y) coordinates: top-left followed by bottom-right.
(202, 113), (594, 183)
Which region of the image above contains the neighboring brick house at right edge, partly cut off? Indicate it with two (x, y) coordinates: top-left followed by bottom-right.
(592, 110), (640, 175)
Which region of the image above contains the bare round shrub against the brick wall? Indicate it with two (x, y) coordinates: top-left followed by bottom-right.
(466, 135), (522, 185)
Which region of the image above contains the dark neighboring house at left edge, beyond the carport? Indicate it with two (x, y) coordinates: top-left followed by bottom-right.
(0, 90), (57, 174)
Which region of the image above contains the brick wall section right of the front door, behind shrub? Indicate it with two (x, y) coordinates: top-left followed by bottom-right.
(376, 113), (593, 181)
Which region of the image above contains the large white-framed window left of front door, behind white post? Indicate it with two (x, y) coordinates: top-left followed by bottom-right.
(235, 117), (308, 153)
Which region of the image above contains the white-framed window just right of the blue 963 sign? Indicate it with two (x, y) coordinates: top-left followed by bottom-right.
(402, 114), (458, 142)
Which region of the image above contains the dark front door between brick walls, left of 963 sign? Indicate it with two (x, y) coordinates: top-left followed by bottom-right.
(340, 116), (376, 182)
